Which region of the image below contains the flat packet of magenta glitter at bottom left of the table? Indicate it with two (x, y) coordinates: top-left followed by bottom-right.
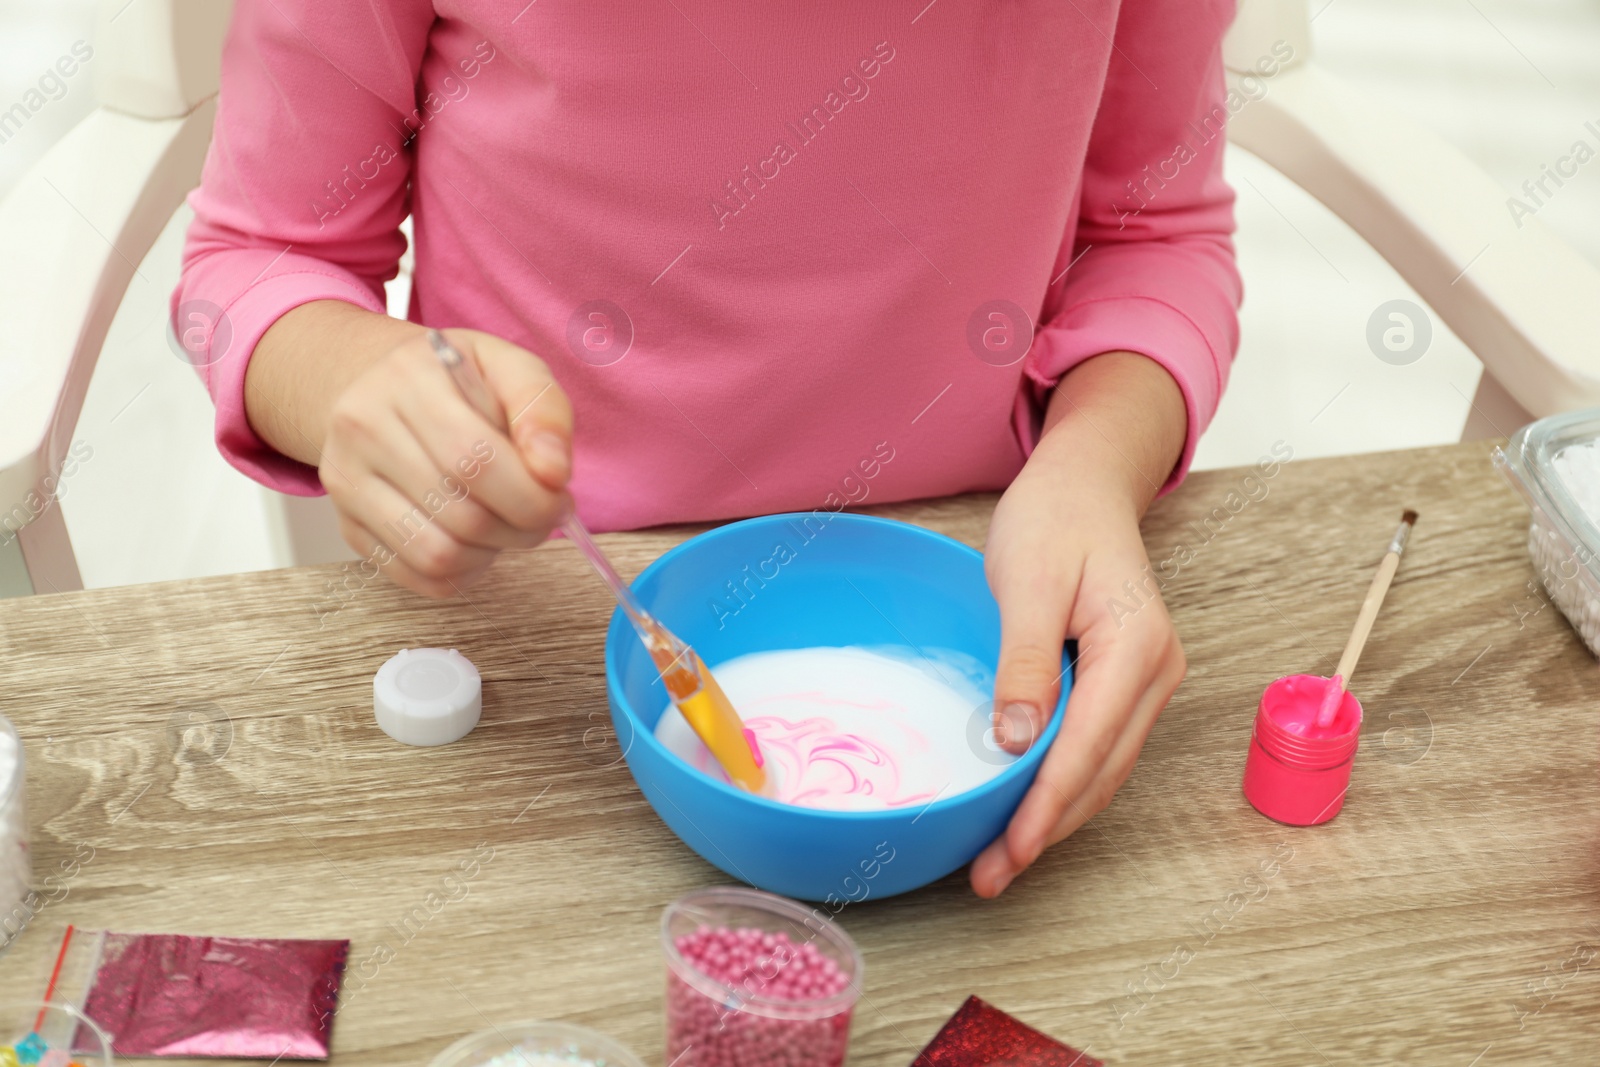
(73, 933), (350, 1059)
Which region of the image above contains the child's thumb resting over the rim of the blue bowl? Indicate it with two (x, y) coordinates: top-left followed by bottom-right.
(994, 572), (1072, 755)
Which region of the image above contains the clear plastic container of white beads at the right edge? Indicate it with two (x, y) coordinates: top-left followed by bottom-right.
(1494, 408), (1600, 656)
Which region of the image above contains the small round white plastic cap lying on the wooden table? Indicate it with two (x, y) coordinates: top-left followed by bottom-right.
(373, 648), (483, 745)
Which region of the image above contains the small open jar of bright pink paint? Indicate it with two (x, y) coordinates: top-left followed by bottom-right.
(1245, 675), (1362, 825)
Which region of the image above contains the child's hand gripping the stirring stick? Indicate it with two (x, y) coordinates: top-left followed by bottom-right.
(317, 330), (573, 597)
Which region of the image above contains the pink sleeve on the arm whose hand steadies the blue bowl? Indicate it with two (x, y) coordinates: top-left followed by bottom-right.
(1024, 0), (1240, 493)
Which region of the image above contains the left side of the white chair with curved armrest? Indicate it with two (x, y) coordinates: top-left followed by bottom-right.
(0, 0), (349, 597)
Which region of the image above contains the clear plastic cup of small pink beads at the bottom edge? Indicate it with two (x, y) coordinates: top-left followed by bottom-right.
(661, 886), (866, 1067)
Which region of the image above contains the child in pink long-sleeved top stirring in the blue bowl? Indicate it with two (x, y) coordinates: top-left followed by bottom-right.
(173, 0), (1240, 896)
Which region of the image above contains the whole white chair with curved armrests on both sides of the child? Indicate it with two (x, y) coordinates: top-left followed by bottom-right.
(0, 0), (1600, 595)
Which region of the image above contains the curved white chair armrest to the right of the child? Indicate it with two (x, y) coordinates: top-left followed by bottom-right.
(1224, 0), (1600, 440)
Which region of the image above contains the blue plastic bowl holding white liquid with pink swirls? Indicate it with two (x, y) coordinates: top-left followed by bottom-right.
(605, 512), (1072, 902)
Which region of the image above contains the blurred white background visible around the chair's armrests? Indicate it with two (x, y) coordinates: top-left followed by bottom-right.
(0, 0), (1600, 587)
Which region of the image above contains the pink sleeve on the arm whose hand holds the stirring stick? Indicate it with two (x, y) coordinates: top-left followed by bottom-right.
(171, 0), (434, 496)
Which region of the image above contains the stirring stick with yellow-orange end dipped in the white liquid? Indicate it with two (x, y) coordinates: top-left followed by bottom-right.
(427, 330), (766, 793)
